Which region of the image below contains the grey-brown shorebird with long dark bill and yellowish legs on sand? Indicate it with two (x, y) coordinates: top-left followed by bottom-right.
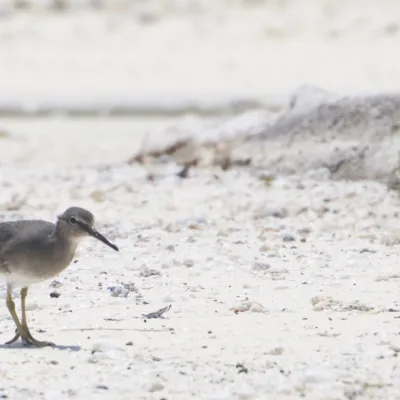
(0, 207), (119, 347)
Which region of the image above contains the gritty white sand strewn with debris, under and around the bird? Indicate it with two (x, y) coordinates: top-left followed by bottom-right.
(0, 126), (400, 399)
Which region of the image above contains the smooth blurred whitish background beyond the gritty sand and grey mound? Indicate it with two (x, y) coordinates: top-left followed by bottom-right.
(0, 0), (400, 163)
